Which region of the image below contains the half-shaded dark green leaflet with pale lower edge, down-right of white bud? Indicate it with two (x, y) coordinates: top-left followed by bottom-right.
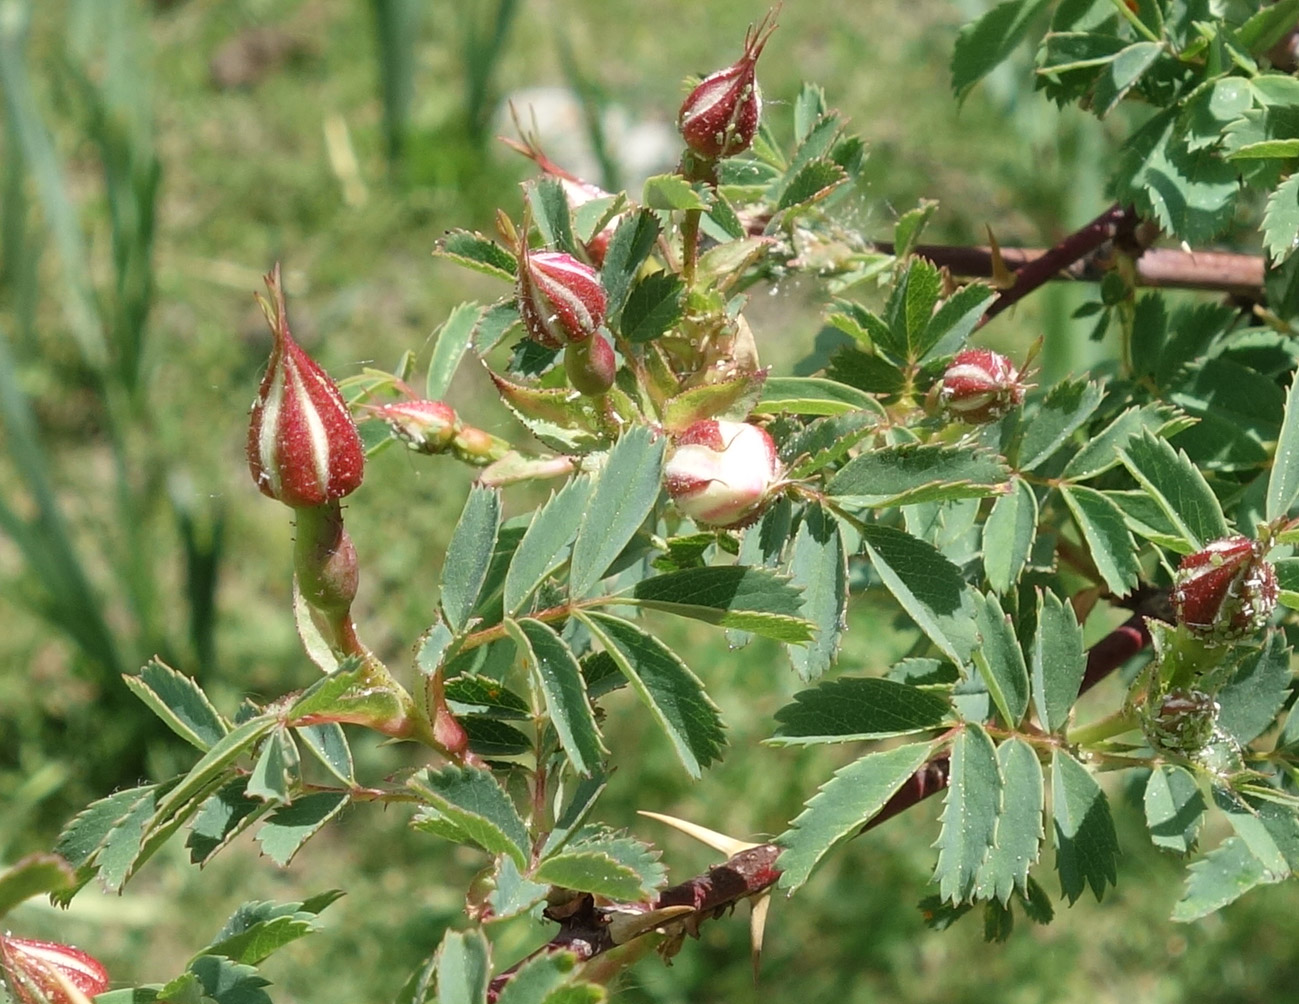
(861, 523), (974, 665)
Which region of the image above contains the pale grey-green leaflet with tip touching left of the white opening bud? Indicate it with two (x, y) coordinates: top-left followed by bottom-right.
(569, 425), (665, 599)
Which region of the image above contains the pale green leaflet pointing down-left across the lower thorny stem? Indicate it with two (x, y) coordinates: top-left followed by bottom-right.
(776, 743), (933, 892)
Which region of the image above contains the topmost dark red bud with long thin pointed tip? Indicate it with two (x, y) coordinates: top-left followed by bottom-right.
(677, 13), (776, 160)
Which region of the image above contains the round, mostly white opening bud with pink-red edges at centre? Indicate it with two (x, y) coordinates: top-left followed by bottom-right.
(664, 418), (783, 526)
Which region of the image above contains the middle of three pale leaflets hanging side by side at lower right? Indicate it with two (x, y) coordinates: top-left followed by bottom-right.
(974, 736), (1044, 904)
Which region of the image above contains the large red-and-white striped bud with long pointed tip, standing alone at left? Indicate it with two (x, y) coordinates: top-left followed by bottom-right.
(248, 265), (365, 509)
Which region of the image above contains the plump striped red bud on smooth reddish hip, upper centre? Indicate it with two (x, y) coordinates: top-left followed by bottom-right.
(518, 248), (608, 348)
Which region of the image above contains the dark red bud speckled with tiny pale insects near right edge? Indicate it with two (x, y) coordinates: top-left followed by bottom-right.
(1173, 536), (1278, 642)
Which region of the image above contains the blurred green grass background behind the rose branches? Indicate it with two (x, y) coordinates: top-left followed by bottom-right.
(0, 0), (1299, 1004)
